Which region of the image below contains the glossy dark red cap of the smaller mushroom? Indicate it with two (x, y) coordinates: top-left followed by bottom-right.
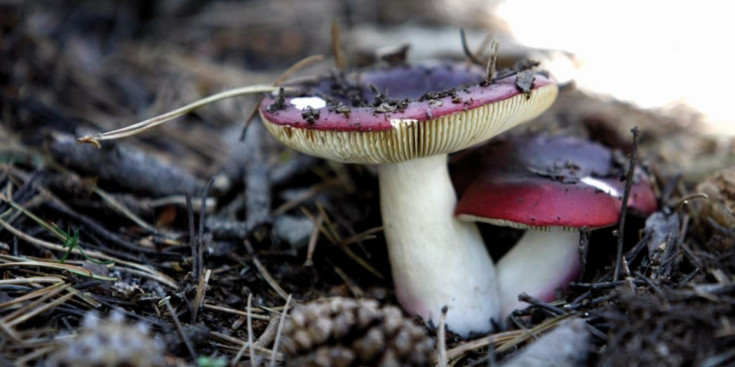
(455, 137), (656, 229)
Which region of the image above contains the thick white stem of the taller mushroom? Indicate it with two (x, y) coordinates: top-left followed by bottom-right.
(379, 154), (500, 337)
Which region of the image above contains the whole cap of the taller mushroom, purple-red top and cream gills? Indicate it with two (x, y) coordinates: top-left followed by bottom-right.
(260, 63), (558, 164)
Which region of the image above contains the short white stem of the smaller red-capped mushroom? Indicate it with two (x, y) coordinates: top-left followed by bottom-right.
(497, 227), (580, 317)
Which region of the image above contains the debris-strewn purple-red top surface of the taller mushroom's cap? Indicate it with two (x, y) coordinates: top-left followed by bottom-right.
(260, 63), (553, 131)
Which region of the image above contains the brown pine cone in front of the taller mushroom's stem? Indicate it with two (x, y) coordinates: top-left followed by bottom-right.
(281, 298), (433, 367)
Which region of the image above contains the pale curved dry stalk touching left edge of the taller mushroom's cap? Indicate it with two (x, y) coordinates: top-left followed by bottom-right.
(77, 85), (278, 148)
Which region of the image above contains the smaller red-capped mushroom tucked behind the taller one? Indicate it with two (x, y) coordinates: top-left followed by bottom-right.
(455, 136), (656, 315)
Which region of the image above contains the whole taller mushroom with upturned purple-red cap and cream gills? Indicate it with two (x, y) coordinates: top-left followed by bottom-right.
(260, 62), (557, 336)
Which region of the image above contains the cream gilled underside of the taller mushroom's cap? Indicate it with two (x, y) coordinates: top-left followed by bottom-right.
(263, 84), (558, 164)
